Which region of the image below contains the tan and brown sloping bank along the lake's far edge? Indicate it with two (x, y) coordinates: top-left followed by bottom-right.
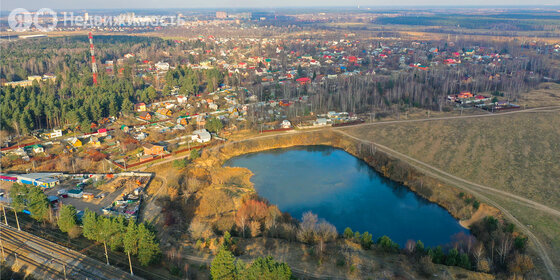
(201, 130), (499, 229)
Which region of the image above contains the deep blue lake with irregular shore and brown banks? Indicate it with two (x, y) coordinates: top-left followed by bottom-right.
(225, 146), (469, 247)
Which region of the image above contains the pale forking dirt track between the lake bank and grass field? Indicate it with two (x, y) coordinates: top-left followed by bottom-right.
(334, 129), (560, 279)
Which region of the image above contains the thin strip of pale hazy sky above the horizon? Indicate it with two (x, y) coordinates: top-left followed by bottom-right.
(4, 0), (559, 11)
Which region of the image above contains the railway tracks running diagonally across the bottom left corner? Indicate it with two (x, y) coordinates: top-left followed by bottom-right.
(0, 224), (142, 280)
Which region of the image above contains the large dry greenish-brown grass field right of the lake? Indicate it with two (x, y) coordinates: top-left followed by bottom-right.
(345, 109), (560, 276)
